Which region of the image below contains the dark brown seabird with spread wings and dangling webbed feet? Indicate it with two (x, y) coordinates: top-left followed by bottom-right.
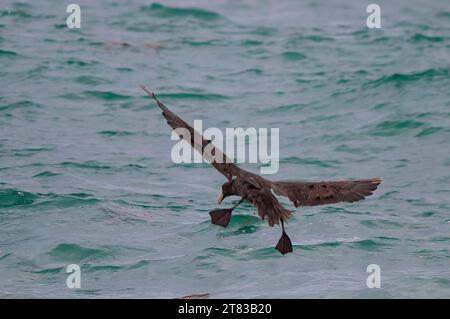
(142, 86), (381, 255)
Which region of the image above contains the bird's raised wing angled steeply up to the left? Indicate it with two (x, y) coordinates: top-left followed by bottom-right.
(141, 86), (245, 181)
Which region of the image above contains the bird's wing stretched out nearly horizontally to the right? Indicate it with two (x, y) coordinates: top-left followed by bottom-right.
(271, 178), (381, 207)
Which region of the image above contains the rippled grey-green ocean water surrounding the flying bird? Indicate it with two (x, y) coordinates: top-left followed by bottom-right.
(0, 0), (450, 298)
